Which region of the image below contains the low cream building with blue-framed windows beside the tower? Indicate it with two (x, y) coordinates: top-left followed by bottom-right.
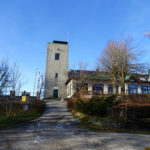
(66, 70), (150, 98)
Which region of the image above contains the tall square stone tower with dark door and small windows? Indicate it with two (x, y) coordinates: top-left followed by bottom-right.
(44, 41), (68, 98)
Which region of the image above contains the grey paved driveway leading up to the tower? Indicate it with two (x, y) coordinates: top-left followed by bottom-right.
(0, 101), (150, 150)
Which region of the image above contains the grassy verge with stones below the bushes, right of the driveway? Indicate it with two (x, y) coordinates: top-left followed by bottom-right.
(73, 112), (150, 134)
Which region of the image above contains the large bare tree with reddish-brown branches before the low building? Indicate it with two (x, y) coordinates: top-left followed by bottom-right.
(98, 38), (144, 93)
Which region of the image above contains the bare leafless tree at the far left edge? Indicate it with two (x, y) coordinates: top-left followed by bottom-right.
(0, 59), (23, 117)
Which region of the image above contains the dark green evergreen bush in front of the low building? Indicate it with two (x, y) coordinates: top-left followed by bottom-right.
(74, 95), (116, 116)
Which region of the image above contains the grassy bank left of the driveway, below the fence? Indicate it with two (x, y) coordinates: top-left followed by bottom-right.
(0, 101), (45, 128)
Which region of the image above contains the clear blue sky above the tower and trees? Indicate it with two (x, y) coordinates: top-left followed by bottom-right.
(0, 0), (150, 91)
